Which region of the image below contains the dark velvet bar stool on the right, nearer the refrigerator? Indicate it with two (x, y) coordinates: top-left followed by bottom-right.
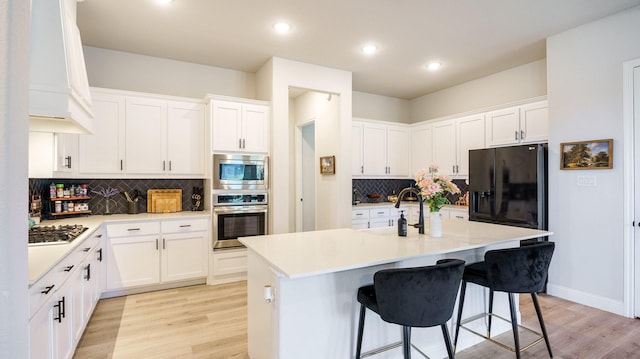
(453, 242), (555, 358)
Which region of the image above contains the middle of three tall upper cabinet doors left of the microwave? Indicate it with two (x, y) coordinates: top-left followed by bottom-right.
(125, 97), (168, 174)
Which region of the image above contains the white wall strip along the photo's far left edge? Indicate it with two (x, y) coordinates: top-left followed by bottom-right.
(0, 0), (30, 358)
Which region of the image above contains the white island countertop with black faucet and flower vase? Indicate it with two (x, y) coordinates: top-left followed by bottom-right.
(240, 219), (553, 279)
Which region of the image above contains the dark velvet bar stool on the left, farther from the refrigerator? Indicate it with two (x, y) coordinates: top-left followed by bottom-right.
(356, 259), (465, 359)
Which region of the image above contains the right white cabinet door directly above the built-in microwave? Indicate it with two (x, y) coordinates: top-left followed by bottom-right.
(241, 105), (269, 153)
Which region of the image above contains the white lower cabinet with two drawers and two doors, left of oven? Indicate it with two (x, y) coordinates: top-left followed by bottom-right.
(105, 218), (209, 292)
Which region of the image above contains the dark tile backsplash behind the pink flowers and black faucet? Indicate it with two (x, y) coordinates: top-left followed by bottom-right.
(351, 179), (469, 204)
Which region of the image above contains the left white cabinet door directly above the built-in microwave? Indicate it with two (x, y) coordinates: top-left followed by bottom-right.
(211, 101), (242, 151)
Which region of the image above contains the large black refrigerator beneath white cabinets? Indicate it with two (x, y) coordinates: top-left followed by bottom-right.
(469, 144), (548, 230)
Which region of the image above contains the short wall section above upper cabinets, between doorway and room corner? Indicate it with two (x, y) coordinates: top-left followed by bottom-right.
(353, 91), (411, 123)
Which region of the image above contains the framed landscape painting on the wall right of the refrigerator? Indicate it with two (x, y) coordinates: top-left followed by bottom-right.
(560, 139), (613, 170)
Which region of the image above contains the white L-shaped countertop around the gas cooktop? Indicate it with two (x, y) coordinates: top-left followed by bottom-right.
(28, 211), (211, 286)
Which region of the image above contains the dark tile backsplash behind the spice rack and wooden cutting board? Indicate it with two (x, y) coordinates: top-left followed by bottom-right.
(29, 178), (204, 219)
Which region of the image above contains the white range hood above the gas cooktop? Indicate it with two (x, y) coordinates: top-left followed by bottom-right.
(29, 0), (93, 134)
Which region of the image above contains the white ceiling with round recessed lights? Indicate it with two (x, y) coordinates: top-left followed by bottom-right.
(78, 0), (640, 99)
